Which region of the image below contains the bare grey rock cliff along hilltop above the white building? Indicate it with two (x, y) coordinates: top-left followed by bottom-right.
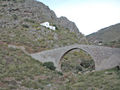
(1, 0), (81, 34)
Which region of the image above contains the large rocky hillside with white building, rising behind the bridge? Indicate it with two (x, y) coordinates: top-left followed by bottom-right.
(0, 0), (86, 52)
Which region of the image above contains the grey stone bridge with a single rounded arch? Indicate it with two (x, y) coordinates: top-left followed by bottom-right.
(30, 44), (120, 71)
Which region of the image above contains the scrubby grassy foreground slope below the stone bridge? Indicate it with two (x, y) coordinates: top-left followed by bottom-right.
(0, 43), (120, 90)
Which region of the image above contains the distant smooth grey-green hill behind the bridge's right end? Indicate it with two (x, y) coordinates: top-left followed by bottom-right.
(87, 23), (120, 47)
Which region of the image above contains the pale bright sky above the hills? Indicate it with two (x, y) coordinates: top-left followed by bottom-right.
(38, 0), (120, 35)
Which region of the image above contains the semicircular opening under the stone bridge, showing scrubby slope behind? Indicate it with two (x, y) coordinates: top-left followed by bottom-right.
(59, 48), (95, 73)
